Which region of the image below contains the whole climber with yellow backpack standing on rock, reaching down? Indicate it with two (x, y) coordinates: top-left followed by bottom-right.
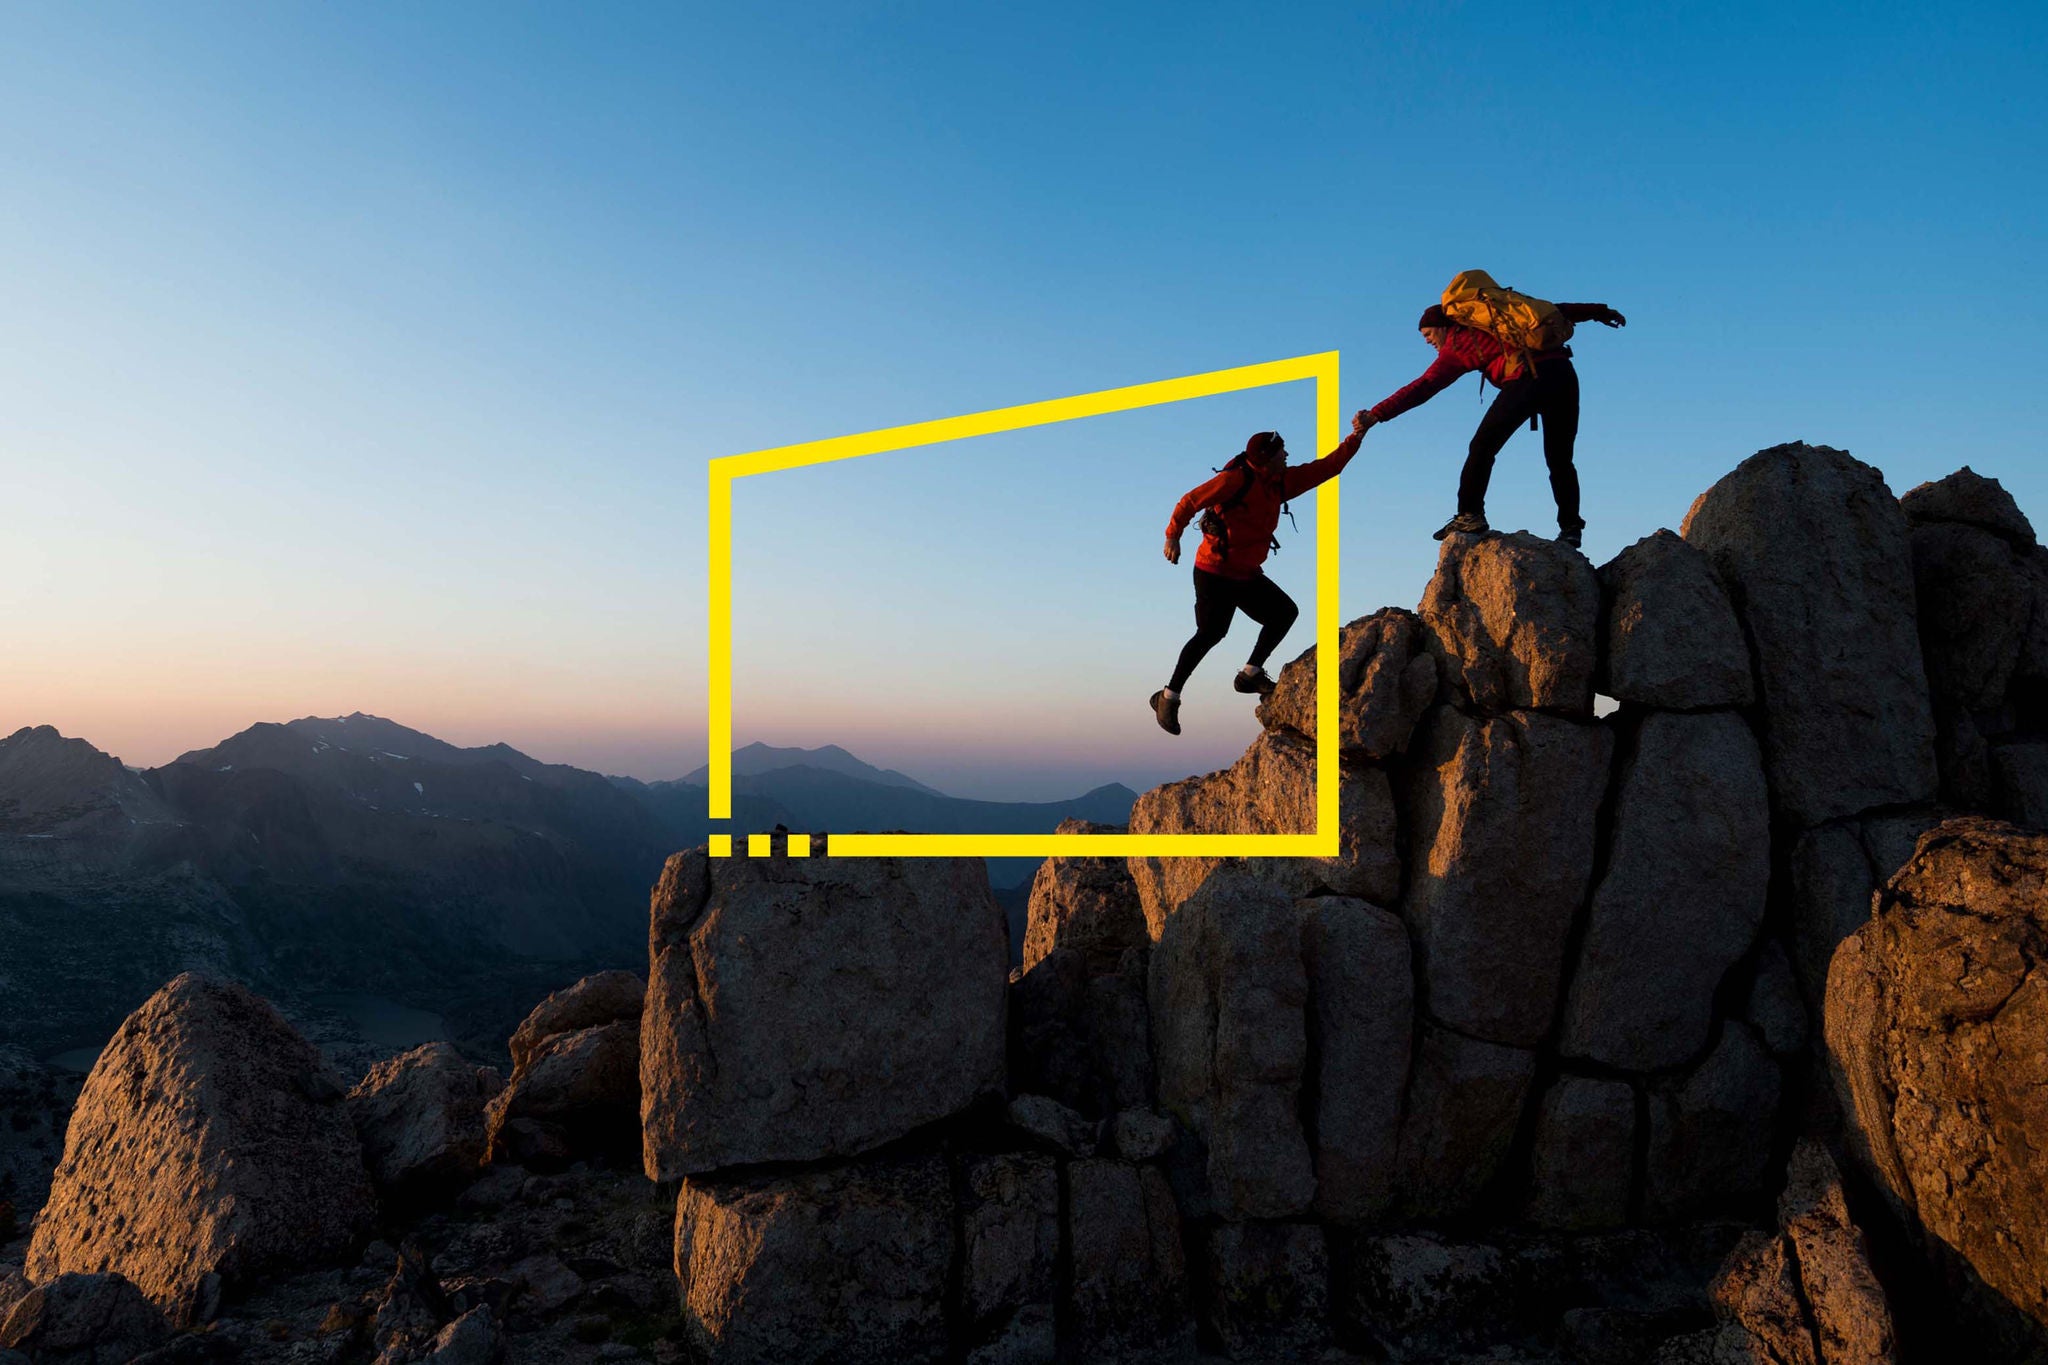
(1360, 270), (1628, 548)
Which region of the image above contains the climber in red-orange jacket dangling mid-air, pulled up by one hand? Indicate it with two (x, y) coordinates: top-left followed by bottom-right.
(1151, 413), (1374, 735)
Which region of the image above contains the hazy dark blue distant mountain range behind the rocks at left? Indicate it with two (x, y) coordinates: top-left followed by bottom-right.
(0, 712), (1135, 1052)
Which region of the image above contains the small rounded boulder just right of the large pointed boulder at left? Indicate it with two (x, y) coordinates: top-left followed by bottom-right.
(348, 1042), (504, 1199)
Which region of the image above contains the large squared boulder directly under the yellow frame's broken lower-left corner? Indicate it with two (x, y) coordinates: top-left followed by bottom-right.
(641, 849), (1010, 1179)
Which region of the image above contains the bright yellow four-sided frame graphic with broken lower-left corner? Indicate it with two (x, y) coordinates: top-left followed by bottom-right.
(709, 350), (1339, 857)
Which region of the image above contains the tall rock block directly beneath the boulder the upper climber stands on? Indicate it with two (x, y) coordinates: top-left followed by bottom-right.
(1401, 703), (1614, 1048)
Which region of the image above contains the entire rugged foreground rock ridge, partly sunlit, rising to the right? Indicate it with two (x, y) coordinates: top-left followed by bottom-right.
(0, 444), (2048, 1365)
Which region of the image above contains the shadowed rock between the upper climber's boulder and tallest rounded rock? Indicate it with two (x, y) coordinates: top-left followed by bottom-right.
(1593, 530), (1755, 710)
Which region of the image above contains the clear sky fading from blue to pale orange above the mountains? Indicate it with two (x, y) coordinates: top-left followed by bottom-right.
(0, 4), (2048, 798)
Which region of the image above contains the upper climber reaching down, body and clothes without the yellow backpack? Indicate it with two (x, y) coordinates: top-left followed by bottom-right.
(1360, 303), (1628, 548)
